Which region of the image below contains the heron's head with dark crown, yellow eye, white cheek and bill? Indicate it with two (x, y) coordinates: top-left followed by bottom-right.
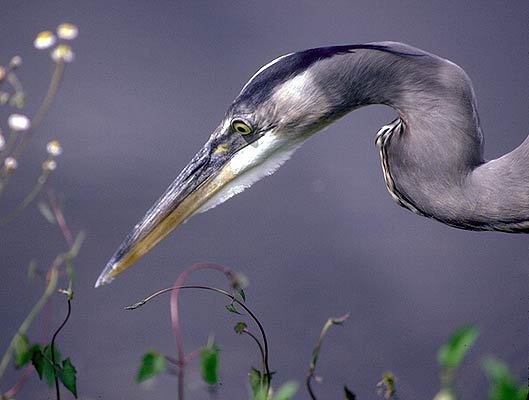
(96, 49), (356, 287)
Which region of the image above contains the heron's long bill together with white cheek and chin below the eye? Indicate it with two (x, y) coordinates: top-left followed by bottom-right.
(95, 123), (301, 287)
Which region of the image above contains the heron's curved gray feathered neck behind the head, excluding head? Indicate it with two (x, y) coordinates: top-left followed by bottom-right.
(313, 42), (529, 232)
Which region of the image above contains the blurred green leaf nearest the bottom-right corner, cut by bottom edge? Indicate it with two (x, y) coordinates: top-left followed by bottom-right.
(483, 357), (528, 400)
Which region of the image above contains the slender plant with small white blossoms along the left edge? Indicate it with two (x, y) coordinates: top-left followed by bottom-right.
(0, 23), (84, 399)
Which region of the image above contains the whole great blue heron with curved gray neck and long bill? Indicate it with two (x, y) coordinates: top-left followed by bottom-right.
(96, 42), (529, 286)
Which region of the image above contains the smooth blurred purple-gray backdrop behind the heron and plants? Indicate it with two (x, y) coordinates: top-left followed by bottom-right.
(0, 0), (529, 399)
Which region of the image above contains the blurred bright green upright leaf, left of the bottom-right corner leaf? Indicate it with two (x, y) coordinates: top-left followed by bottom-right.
(437, 326), (479, 369)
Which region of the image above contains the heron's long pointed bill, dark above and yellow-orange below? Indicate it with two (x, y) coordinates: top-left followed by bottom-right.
(95, 133), (236, 287)
